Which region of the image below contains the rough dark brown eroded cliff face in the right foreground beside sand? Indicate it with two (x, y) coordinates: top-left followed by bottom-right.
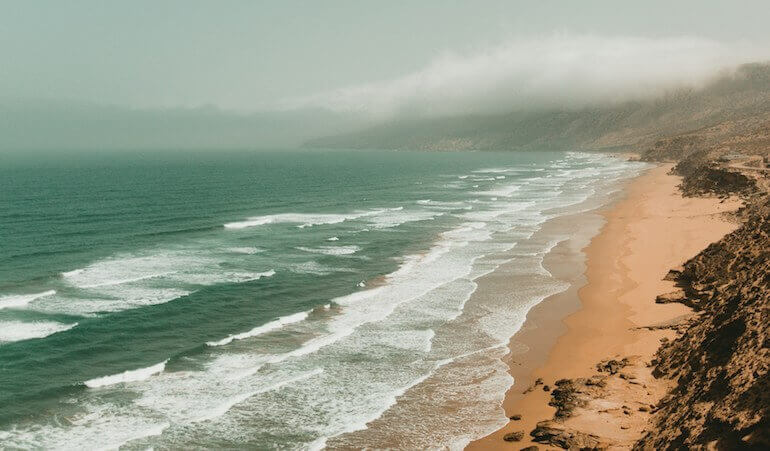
(636, 201), (770, 449)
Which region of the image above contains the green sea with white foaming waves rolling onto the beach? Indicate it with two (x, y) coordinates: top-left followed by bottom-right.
(0, 151), (640, 449)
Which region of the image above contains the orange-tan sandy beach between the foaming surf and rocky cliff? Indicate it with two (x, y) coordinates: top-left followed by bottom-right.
(467, 164), (740, 449)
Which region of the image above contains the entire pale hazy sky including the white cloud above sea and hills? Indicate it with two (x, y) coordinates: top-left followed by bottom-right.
(0, 0), (770, 152)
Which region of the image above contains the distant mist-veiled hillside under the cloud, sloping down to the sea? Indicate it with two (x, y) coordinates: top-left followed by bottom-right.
(305, 63), (770, 150)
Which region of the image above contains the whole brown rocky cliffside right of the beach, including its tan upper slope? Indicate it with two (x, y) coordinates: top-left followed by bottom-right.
(635, 121), (770, 449)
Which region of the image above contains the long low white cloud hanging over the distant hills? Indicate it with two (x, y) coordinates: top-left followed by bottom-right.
(281, 34), (770, 119)
